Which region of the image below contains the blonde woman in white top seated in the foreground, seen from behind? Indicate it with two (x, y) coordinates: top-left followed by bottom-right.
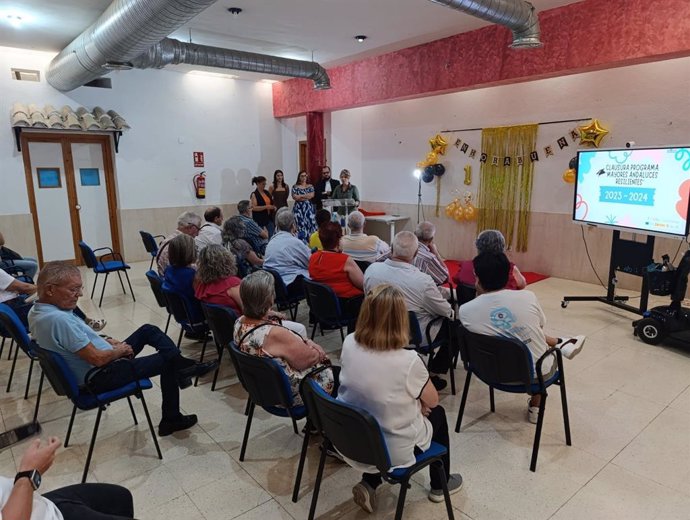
(338, 284), (462, 513)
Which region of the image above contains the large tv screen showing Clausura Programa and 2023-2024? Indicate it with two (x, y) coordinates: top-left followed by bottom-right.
(573, 147), (690, 237)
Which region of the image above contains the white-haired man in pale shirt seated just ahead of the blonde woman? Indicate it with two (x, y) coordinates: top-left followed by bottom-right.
(364, 231), (453, 390)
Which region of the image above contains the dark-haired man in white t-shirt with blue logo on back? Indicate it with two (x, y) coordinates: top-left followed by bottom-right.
(458, 253), (585, 423)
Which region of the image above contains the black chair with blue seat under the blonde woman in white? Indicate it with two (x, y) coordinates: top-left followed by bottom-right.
(303, 379), (455, 520)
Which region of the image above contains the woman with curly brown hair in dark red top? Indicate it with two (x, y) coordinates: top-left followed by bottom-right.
(194, 244), (242, 316)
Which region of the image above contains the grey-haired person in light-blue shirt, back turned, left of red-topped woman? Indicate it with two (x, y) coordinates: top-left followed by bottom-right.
(264, 208), (311, 293)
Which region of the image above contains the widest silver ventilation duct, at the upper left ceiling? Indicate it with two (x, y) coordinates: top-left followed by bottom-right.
(46, 0), (216, 92)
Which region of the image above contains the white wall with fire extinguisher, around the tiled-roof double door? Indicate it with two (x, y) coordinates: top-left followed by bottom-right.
(0, 47), (283, 215)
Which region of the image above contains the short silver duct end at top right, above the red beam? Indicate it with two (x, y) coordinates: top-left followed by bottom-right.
(430, 0), (542, 49)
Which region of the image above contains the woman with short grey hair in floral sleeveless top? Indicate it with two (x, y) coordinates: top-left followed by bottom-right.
(234, 271), (334, 404)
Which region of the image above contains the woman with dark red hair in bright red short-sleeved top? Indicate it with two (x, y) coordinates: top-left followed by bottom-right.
(309, 222), (364, 333)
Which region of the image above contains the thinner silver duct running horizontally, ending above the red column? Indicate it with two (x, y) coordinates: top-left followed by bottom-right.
(132, 38), (331, 90)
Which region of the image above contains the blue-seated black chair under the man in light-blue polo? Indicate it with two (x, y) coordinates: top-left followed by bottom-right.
(35, 346), (163, 483)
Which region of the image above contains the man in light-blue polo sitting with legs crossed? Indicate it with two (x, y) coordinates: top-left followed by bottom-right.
(29, 262), (218, 436)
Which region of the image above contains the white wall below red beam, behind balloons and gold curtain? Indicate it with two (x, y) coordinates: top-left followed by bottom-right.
(326, 58), (690, 213)
